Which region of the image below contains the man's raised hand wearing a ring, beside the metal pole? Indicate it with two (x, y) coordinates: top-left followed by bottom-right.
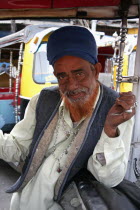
(104, 92), (136, 137)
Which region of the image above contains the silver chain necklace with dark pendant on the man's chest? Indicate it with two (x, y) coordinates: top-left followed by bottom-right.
(52, 108), (79, 173)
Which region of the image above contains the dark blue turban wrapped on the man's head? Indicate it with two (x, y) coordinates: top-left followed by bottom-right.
(47, 26), (98, 65)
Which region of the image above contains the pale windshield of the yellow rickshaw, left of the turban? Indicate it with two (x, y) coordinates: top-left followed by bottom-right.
(33, 42), (57, 84)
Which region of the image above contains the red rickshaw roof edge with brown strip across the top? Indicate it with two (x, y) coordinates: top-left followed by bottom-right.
(0, 0), (139, 19)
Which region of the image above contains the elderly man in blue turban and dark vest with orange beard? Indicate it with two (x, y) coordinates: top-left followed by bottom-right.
(0, 26), (135, 210)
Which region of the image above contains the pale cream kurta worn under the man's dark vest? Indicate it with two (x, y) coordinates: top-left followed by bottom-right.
(0, 88), (133, 210)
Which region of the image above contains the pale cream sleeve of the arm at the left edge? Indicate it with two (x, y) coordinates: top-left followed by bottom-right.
(0, 95), (38, 162)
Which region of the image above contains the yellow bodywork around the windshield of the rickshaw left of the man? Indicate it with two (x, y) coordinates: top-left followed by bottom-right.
(20, 35), (57, 99)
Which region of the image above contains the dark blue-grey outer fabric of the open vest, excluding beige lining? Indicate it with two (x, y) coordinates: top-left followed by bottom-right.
(7, 85), (118, 200)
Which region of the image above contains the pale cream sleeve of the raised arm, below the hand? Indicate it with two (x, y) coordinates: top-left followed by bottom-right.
(87, 118), (134, 187)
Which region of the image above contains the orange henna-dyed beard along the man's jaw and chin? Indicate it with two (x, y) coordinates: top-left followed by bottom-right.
(62, 83), (99, 122)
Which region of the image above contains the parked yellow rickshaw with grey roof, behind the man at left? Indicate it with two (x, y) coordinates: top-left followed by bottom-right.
(0, 25), (60, 131)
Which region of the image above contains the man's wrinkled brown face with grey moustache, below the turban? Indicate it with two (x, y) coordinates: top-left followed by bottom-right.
(54, 56), (100, 104)
